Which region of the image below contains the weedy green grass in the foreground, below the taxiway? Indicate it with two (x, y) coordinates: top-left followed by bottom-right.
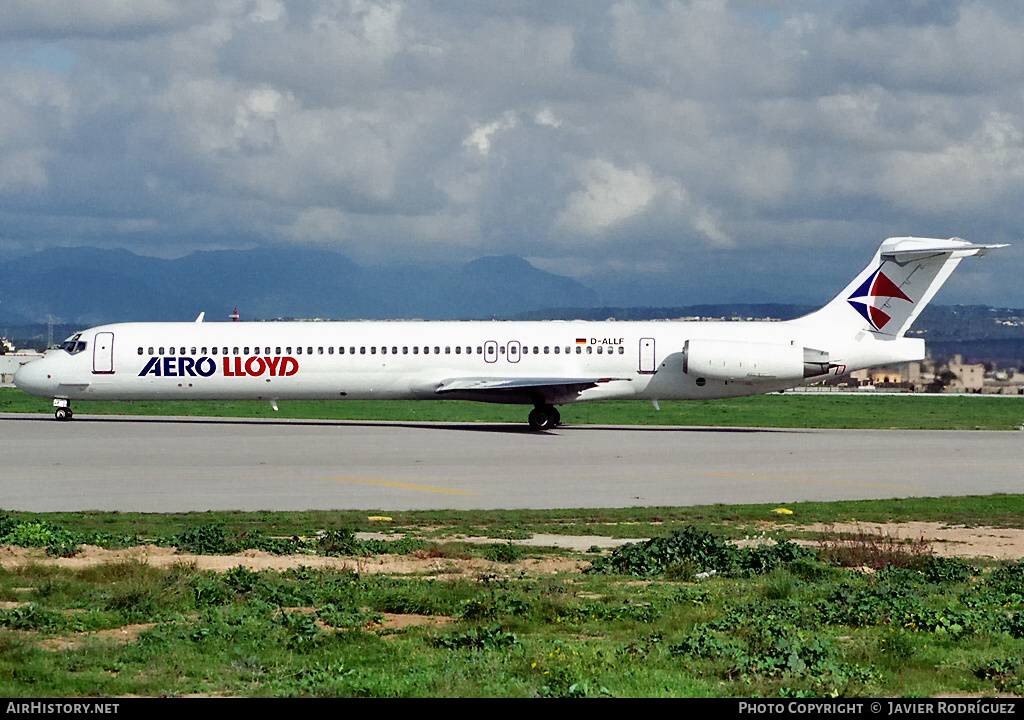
(0, 496), (1024, 697)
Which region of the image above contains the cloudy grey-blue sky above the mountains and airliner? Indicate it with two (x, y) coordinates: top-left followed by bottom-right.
(0, 0), (1024, 307)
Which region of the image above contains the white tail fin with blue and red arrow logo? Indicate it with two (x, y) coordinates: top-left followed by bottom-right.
(800, 238), (1006, 339)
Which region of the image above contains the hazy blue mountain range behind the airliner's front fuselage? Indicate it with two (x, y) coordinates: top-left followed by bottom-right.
(0, 247), (597, 325)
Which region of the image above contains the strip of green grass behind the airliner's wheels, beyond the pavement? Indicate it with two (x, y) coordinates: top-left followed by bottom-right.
(0, 388), (1024, 430)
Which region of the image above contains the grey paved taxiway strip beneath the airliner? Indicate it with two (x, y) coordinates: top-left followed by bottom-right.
(0, 415), (1024, 512)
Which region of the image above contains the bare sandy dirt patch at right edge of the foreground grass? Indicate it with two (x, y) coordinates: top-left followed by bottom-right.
(799, 522), (1024, 560)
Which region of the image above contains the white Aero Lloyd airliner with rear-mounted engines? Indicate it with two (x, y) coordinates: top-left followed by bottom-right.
(14, 238), (1005, 430)
